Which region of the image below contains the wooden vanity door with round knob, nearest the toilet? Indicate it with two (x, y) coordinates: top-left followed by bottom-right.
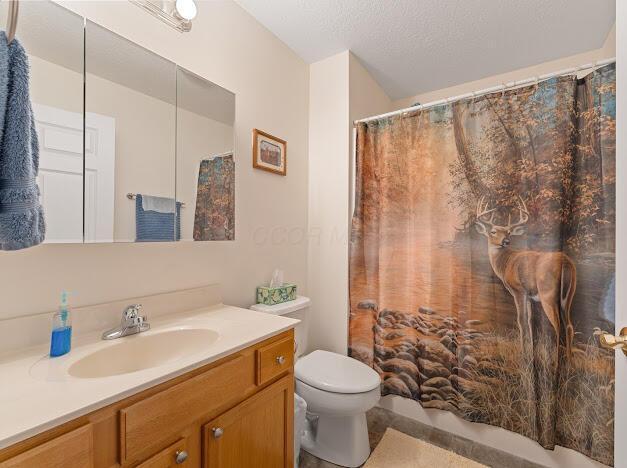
(203, 374), (294, 468)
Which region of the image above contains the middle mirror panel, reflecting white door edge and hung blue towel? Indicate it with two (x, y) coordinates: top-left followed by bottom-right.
(84, 21), (180, 242)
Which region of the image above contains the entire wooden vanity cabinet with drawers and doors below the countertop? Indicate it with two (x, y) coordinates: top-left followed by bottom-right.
(0, 330), (294, 468)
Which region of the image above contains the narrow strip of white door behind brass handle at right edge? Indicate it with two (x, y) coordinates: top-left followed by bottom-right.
(614, 0), (627, 468)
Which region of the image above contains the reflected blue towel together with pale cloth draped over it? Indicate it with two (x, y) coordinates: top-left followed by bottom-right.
(135, 194), (181, 242)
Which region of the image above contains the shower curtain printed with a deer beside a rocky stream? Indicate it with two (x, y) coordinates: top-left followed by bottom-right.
(349, 65), (616, 464)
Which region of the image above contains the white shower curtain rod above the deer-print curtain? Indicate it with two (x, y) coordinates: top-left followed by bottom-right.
(353, 57), (616, 126)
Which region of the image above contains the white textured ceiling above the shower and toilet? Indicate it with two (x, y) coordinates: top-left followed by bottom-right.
(237, 0), (615, 99)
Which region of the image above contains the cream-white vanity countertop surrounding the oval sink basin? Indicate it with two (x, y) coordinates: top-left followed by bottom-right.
(0, 305), (298, 448)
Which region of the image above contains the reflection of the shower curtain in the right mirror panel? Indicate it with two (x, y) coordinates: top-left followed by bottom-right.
(194, 154), (235, 241)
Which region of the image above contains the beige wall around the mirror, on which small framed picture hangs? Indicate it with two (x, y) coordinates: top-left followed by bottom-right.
(0, 1), (309, 317)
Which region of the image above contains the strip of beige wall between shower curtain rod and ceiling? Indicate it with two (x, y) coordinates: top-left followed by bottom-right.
(392, 26), (616, 110)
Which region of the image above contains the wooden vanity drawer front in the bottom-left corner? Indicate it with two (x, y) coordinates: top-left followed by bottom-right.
(0, 424), (94, 468)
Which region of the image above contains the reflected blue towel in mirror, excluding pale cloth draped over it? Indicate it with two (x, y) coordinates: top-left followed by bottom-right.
(135, 194), (181, 242)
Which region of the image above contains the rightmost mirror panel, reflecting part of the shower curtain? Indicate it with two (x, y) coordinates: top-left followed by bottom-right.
(176, 67), (235, 241)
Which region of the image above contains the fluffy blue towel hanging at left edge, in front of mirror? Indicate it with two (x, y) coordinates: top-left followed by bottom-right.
(0, 32), (46, 250)
